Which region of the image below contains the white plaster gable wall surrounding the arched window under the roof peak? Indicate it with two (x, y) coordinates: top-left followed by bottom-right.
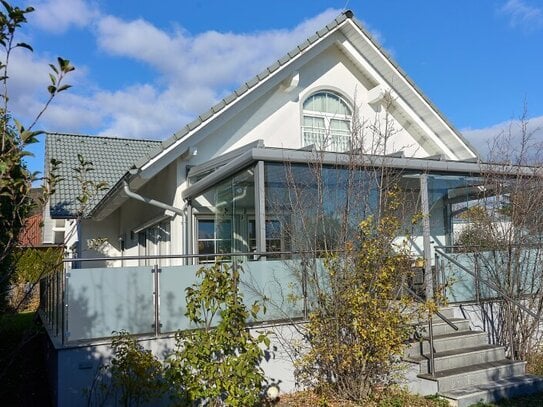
(196, 45), (428, 162)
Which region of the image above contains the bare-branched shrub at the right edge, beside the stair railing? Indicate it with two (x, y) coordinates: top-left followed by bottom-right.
(453, 109), (543, 360)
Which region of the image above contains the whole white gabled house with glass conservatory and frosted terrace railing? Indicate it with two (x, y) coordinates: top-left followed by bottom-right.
(42, 11), (543, 405)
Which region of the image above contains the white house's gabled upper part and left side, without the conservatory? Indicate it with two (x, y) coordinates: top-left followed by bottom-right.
(44, 11), (477, 266)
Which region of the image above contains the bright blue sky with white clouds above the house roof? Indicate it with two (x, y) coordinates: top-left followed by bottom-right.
(10, 0), (543, 174)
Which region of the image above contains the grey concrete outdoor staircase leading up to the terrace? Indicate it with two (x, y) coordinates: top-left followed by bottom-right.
(405, 308), (543, 407)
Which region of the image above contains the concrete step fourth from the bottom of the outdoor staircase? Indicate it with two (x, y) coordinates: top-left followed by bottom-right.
(405, 331), (488, 358)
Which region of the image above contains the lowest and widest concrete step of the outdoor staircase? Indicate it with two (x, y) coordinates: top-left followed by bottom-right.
(440, 375), (543, 407)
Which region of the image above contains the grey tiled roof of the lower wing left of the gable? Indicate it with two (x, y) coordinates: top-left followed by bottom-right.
(45, 133), (160, 218)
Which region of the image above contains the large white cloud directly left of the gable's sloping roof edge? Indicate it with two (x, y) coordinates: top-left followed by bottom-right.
(69, 9), (339, 139)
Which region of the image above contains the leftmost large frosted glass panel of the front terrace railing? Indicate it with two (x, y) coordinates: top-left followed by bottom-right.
(66, 267), (154, 342)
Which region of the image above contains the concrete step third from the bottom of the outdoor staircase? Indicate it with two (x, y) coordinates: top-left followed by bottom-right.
(412, 345), (505, 374)
